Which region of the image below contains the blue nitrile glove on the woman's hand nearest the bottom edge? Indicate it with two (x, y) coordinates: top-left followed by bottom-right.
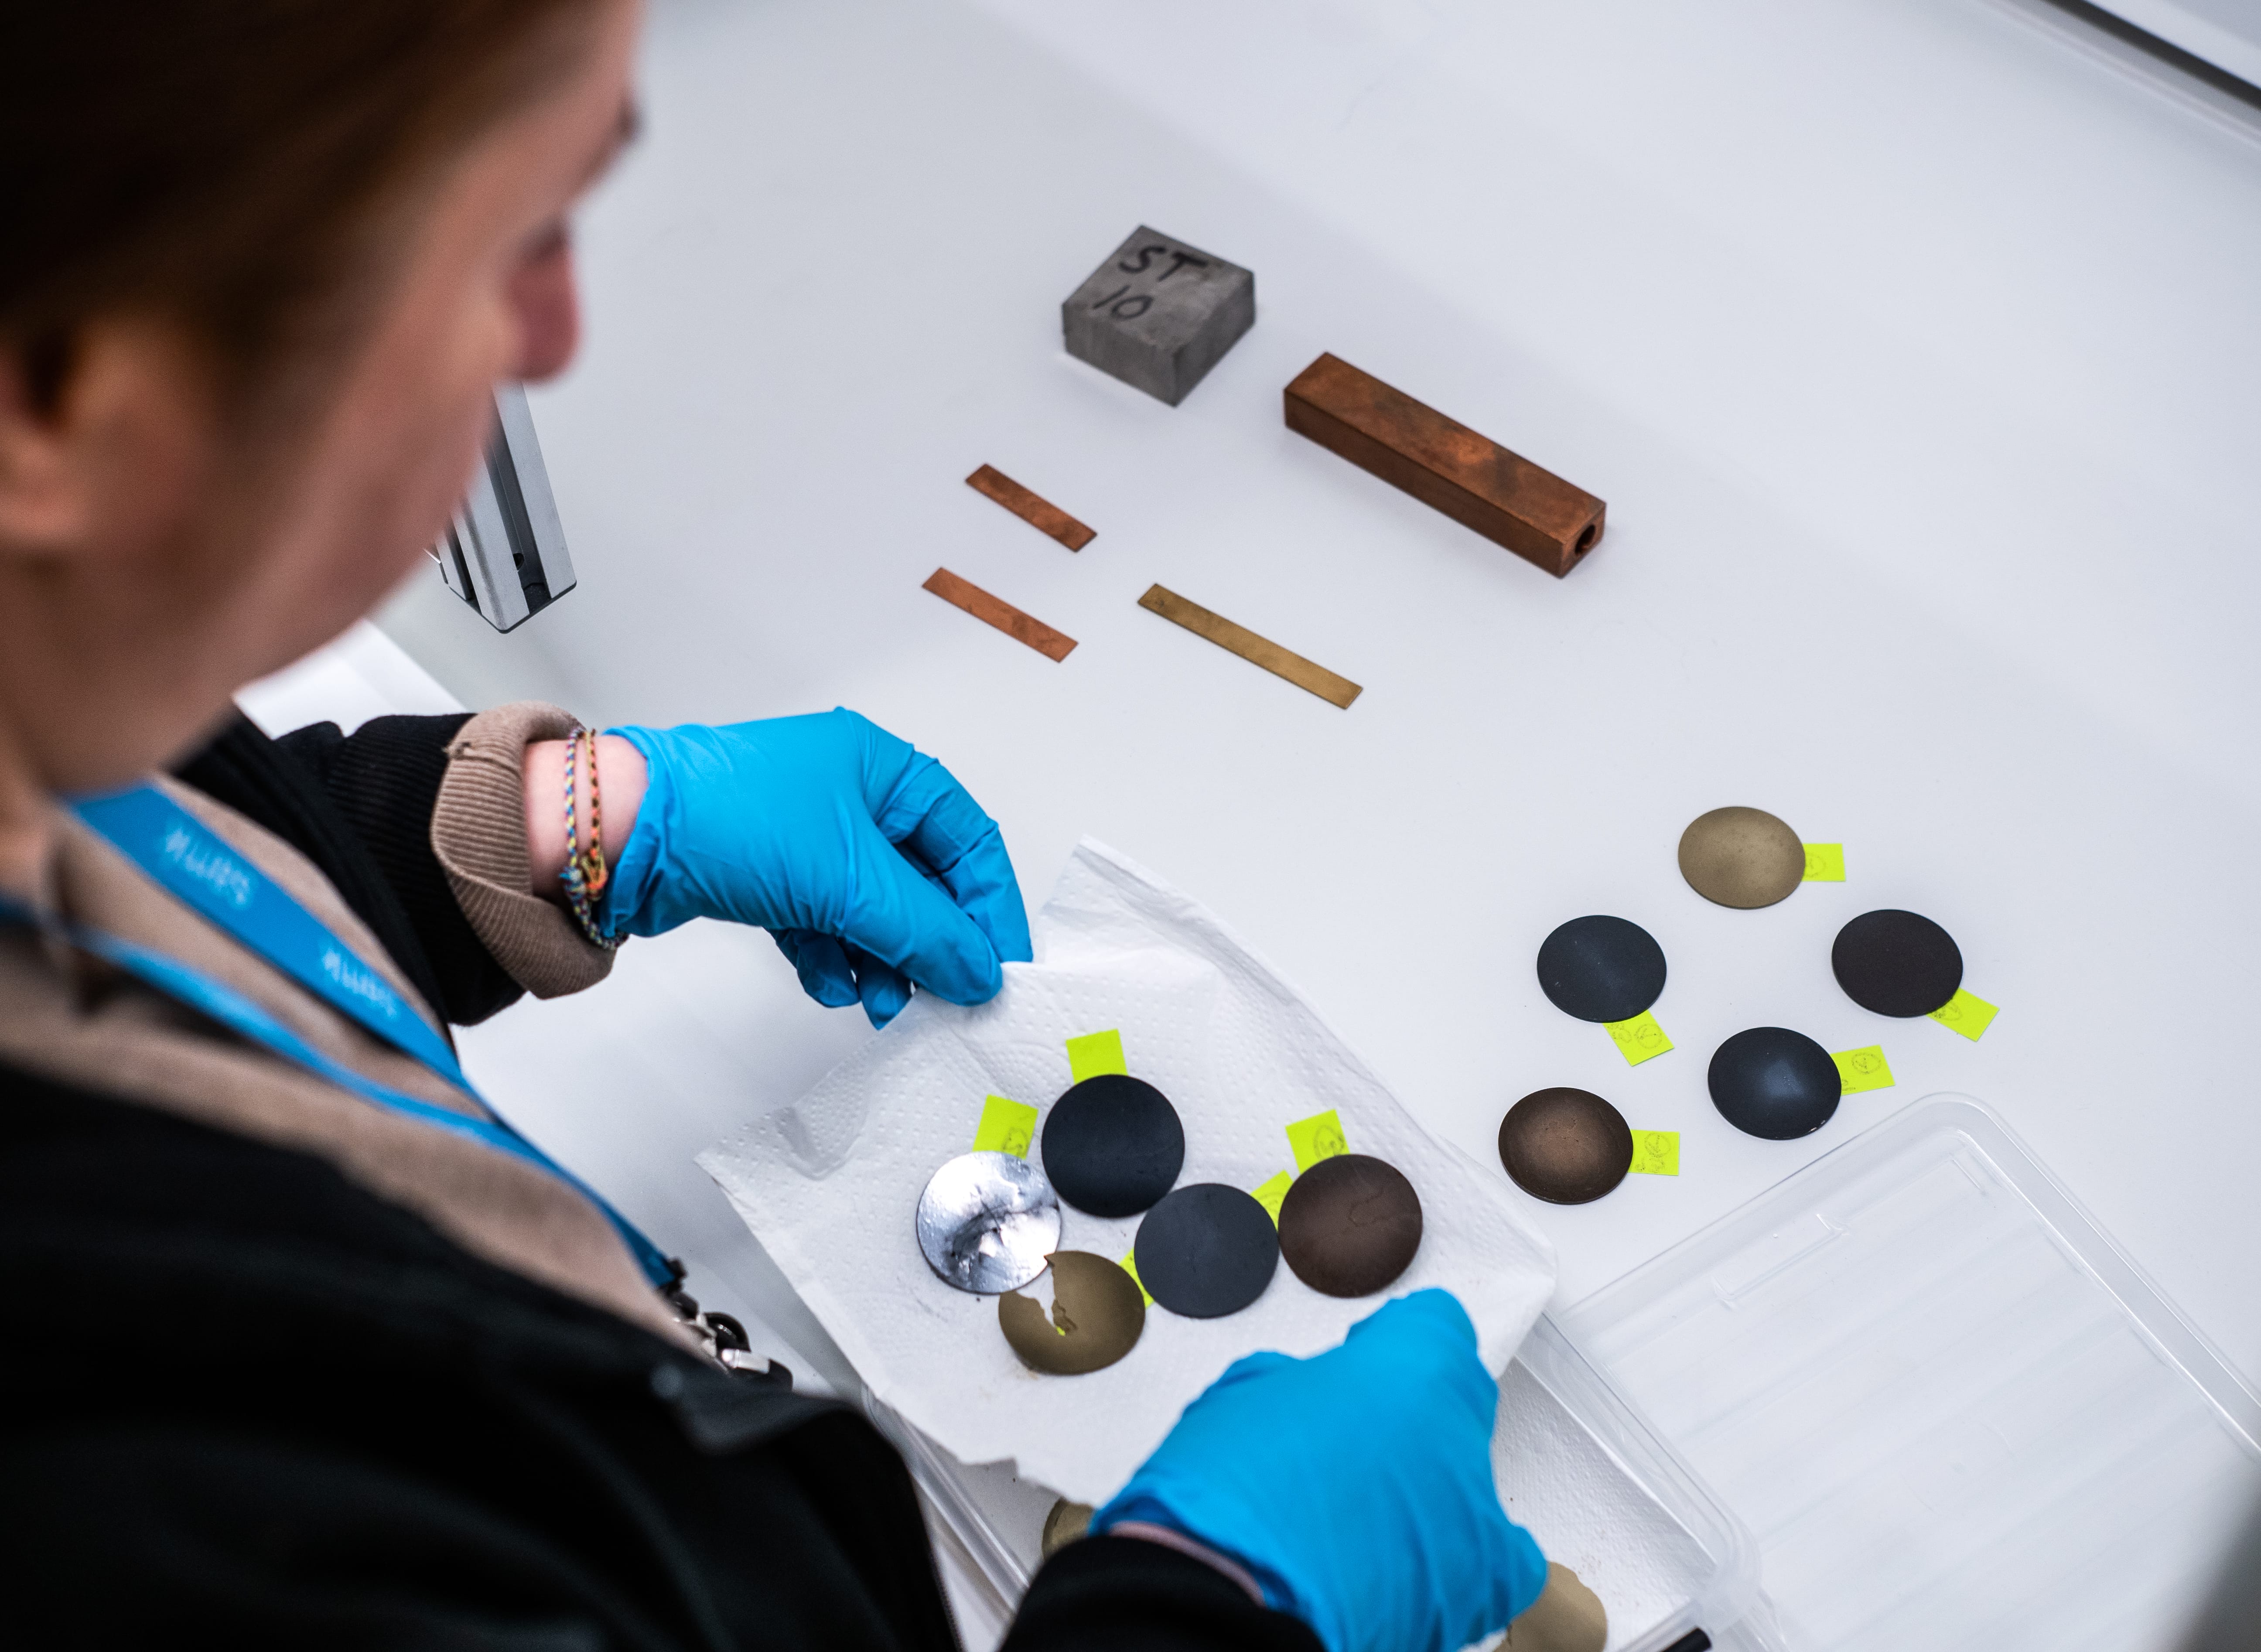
(1092, 1290), (1547, 1652)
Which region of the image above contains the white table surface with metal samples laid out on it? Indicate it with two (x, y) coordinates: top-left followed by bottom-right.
(357, 0), (2261, 1636)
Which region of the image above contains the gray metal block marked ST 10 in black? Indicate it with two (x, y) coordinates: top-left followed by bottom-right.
(1060, 224), (1257, 407)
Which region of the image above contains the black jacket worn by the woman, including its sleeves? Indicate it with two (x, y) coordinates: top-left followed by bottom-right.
(0, 719), (1318, 1652)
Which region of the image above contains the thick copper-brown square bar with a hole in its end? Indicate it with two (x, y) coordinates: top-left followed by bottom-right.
(1287, 355), (1610, 579)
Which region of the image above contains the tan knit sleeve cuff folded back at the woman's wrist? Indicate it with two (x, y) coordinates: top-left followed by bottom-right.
(432, 700), (613, 999)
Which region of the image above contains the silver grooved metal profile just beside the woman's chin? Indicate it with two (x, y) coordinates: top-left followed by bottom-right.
(432, 384), (574, 631)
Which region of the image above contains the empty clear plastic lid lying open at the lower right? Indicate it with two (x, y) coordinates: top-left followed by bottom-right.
(1560, 1096), (2261, 1652)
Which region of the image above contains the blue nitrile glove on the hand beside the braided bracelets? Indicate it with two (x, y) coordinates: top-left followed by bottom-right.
(604, 710), (1029, 1026)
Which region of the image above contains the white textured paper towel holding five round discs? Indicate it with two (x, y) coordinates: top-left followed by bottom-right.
(699, 841), (1553, 1503)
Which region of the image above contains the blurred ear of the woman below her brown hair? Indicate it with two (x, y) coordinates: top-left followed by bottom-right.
(0, 321), (212, 558)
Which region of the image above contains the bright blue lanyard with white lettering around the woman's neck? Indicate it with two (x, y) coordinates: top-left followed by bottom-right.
(44, 786), (680, 1288)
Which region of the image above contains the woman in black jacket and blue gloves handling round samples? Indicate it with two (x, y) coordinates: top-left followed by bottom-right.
(0, 0), (1544, 1652)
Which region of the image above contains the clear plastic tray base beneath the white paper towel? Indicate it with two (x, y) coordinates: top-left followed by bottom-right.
(864, 1318), (1779, 1652)
